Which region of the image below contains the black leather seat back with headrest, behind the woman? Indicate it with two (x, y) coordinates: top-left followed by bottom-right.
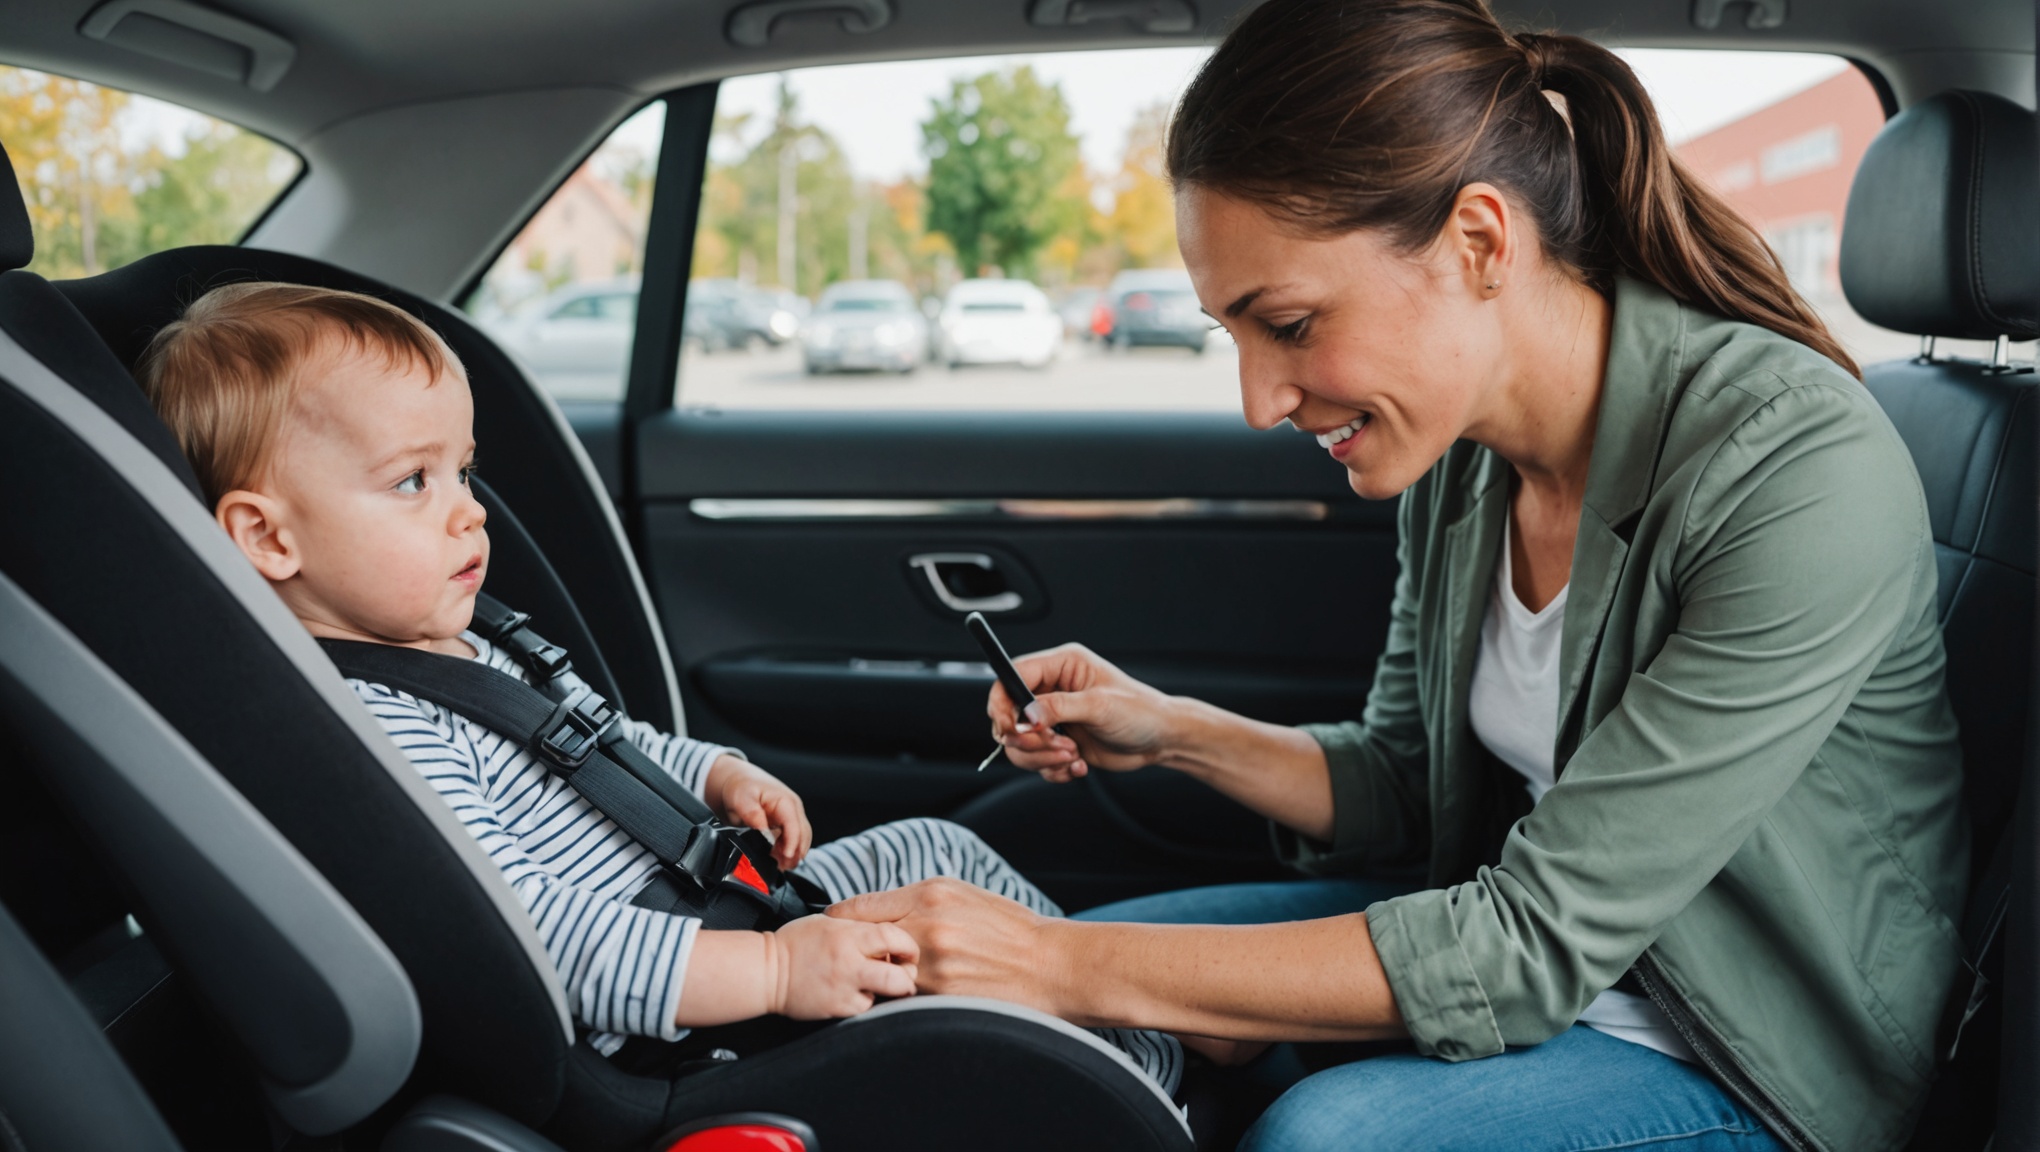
(1840, 92), (2040, 1150)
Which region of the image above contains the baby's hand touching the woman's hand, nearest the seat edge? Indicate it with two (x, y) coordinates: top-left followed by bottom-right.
(765, 915), (920, 1019)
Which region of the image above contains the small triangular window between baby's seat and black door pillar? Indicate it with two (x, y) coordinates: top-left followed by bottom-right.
(465, 102), (665, 402)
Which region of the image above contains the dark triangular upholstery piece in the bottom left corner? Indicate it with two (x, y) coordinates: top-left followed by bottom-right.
(0, 907), (177, 1152)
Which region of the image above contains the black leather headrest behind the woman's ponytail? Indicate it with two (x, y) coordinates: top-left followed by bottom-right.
(1840, 92), (2040, 341)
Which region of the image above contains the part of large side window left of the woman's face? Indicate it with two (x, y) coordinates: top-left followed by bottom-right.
(677, 49), (1238, 410)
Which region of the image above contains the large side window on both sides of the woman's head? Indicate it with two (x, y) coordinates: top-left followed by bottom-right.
(677, 49), (1979, 410)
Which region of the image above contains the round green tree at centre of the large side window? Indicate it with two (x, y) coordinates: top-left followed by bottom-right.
(920, 65), (1085, 275)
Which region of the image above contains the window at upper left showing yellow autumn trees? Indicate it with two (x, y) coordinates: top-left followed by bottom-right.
(0, 65), (304, 279)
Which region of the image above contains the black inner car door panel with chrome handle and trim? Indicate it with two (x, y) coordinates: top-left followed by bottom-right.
(636, 410), (1395, 907)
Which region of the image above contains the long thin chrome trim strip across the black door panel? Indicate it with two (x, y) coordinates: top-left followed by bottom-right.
(687, 495), (1332, 522)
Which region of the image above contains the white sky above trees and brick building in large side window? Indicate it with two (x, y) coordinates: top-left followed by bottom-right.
(701, 49), (1848, 181)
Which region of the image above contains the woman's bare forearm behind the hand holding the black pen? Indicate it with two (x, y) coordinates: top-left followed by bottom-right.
(1157, 697), (1332, 840)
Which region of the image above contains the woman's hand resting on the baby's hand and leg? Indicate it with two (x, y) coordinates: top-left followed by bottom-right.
(828, 877), (1067, 1013)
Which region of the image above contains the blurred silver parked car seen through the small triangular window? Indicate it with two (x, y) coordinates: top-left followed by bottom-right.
(486, 279), (639, 398)
